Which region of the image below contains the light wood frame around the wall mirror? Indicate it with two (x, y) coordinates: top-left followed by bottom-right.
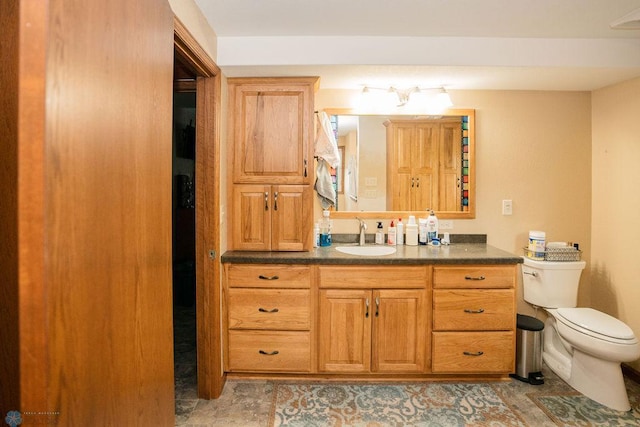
(324, 108), (476, 219)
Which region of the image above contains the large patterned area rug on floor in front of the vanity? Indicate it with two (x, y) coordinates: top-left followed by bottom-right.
(269, 383), (525, 427)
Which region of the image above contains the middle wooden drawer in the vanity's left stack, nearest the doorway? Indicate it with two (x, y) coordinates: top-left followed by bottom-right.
(228, 288), (311, 330)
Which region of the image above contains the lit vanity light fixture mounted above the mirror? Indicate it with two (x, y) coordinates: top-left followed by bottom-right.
(362, 86), (453, 110)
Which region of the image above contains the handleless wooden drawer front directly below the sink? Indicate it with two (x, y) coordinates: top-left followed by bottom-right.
(318, 265), (430, 289)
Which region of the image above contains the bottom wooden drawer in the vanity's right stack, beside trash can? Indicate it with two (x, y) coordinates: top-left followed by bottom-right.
(432, 332), (515, 373)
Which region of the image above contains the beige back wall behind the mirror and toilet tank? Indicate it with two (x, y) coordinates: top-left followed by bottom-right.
(316, 90), (592, 312)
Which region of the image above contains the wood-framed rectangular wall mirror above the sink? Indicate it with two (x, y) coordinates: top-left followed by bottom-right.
(324, 109), (476, 219)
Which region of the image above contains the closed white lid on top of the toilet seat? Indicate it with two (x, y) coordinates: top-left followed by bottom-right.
(556, 307), (635, 340)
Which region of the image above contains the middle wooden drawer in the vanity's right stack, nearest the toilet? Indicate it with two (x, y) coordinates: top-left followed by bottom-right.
(433, 289), (516, 331)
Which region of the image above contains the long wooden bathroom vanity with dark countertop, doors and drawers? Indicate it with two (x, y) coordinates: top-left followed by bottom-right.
(222, 243), (522, 380)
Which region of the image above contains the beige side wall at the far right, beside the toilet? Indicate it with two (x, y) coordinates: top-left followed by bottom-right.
(591, 78), (640, 370)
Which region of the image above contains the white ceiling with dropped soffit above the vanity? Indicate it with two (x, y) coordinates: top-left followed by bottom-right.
(195, 0), (640, 90)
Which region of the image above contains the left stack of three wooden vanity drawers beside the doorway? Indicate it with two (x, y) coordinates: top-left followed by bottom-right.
(223, 264), (315, 373)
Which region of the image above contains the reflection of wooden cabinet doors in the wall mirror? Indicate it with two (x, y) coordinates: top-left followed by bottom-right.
(385, 117), (463, 211)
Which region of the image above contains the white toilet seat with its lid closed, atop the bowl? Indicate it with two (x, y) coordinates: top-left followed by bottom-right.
(555, 307), (638, 345)
